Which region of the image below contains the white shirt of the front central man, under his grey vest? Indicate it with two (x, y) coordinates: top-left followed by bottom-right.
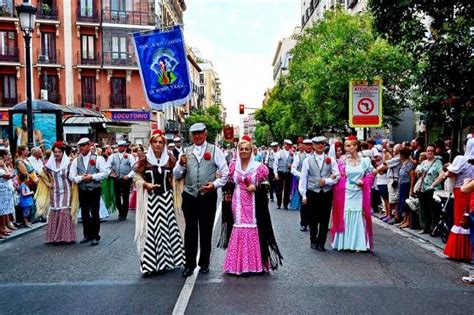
(173, 141), (229, 189)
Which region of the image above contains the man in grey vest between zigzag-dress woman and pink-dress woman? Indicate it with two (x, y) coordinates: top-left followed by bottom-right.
(173, 123), (229, 277)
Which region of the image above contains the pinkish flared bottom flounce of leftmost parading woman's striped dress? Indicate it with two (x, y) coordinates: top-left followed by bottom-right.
(46, 209), (76, 243)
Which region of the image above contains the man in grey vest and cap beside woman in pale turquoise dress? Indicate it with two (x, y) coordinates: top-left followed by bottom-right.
(299, 136), (340, 252)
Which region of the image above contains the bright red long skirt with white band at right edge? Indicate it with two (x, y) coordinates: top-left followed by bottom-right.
(444, 188), (472, 261)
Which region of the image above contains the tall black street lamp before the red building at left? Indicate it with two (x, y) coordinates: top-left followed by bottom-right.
(16, 0), (36, 149)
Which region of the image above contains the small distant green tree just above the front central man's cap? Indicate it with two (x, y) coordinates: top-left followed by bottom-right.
(185, 105), (224, 143)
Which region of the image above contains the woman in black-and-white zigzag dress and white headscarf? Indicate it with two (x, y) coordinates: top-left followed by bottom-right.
(134, 130), (185, 276)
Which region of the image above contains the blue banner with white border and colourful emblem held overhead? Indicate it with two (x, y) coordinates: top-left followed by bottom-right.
(133, 26), (192, 111)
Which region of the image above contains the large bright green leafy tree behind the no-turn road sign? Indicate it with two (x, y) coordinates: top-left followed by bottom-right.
(257, 8), (413, 140)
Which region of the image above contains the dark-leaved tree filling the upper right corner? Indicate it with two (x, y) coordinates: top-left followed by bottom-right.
(369, 0), (474, 151)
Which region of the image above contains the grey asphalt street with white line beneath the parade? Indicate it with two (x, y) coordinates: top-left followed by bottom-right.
(0, 203), (474, 314)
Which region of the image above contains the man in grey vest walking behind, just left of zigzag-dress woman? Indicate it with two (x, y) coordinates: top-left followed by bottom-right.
(109, 140), (136, 221)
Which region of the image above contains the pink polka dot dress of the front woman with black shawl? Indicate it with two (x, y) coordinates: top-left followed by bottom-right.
(224, 162), (269, 275)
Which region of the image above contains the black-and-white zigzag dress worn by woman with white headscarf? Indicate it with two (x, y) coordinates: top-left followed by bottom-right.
(140, 165), (184, 273)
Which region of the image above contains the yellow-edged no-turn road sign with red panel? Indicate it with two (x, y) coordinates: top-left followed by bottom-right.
(349, 79), (382, 128)
